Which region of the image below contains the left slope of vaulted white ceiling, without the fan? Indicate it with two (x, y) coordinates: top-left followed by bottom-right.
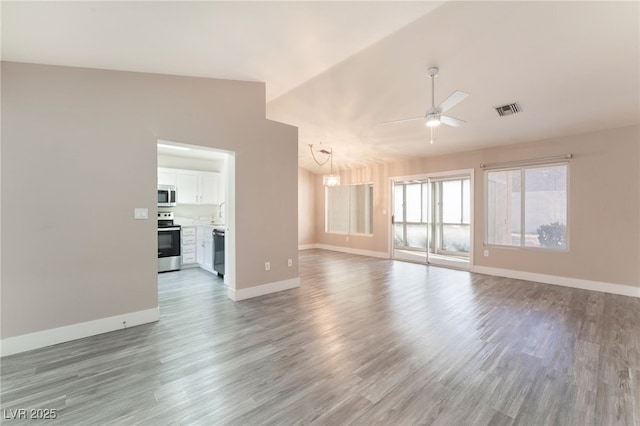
(2, 1), (438, 100)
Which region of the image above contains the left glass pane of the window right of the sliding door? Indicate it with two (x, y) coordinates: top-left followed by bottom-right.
(485, 170), (521, 246)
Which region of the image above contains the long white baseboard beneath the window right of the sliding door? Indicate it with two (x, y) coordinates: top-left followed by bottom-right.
(471, 266), (640, 297)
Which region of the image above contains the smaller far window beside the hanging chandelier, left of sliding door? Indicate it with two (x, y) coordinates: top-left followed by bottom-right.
(325, 184), (373, 234)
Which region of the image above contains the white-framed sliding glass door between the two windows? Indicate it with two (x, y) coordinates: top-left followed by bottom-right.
(392, 170), (473, 270)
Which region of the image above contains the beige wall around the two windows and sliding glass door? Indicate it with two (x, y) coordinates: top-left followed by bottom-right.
(315, 126), (640, 287)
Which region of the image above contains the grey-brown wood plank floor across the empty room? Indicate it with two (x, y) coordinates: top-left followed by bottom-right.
(0, 250), (640, 426)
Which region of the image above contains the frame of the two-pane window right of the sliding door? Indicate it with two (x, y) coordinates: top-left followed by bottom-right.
(483, 161), (571, 253)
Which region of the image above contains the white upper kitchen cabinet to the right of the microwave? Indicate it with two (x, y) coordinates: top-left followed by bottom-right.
(176, 170), (222, 204)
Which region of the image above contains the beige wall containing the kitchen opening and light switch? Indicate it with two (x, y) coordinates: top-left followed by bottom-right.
(1, 62), (298, 339)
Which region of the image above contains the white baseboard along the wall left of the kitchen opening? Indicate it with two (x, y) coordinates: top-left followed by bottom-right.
(0, 308), (160, 356)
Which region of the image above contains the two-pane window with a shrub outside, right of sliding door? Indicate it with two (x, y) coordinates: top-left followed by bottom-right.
(485, 164), (568, 250)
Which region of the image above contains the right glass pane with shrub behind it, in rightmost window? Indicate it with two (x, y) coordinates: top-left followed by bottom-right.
(524, 165), (567, 249)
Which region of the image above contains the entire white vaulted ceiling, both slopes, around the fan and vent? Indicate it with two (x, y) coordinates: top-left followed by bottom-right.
(2, 1), (640, 172)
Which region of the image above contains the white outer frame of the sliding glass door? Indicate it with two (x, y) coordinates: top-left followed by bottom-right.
(389, 168), (476, 270)
